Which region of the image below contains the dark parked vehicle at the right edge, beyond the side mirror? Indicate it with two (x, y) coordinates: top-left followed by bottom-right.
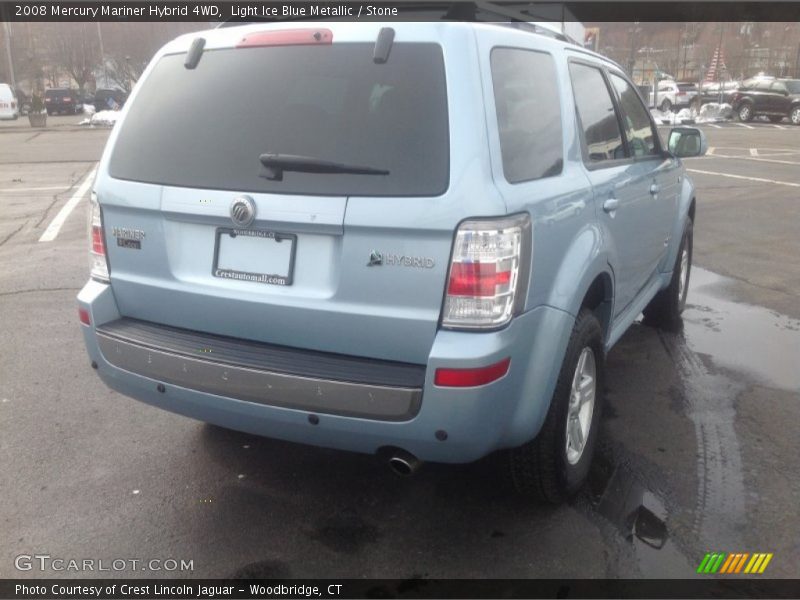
(731, 78), (800, 125)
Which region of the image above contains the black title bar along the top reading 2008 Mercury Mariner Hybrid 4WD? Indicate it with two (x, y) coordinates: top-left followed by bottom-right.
(0, 0), (800, 23)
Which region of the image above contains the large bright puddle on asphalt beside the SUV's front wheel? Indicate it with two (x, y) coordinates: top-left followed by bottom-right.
(683, 267), (800, 391)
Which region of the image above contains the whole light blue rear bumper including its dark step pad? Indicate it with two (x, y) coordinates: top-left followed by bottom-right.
(78, 281), (573, 463)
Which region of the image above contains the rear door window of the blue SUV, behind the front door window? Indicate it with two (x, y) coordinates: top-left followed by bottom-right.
(569, 63), (625, 162)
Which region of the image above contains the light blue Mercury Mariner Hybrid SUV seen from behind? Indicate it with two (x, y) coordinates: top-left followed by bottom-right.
(78, 22), (705, 501)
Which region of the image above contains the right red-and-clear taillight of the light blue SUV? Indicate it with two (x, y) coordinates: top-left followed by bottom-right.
(442, 214), (531, 329)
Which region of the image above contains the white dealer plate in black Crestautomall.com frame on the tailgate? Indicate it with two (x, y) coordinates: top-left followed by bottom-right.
(211, 227), (297, 285)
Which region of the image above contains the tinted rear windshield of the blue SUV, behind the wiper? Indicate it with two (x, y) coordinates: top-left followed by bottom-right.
(109, 43), (449, 196)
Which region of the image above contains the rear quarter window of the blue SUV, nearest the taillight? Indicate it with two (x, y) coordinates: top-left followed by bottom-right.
(491, 48), (563, 183)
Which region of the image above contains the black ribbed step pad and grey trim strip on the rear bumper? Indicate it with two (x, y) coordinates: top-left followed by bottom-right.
(95, 318), (425, 421)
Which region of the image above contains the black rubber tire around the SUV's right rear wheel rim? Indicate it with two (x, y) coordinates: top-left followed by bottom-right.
(508, 308), (605, 504)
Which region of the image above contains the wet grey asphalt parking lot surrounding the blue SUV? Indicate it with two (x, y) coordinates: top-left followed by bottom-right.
(0, 116), (800, 579)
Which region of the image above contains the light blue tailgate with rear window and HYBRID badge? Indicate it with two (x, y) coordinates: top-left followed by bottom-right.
(96, 24), (494, 364)
